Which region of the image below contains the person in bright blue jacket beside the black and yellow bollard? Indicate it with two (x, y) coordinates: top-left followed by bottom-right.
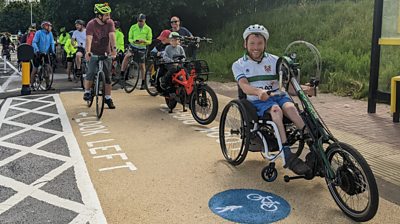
(31, 21), (55, 89)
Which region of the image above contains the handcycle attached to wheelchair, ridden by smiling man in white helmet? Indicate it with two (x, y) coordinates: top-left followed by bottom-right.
(219, 42), (379, 222)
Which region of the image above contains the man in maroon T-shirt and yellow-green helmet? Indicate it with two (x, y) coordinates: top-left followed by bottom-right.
(83, 3), (117, 109)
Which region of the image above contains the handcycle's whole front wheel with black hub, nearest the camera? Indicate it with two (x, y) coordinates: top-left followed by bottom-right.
(326, 143), (379, 222)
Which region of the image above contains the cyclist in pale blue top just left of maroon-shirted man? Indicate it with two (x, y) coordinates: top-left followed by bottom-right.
(72, 19), (86, 75)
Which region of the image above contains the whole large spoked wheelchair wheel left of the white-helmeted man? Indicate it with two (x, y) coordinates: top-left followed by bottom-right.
(219, 100), (250, 166)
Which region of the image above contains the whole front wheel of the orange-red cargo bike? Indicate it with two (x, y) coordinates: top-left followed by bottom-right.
(190, 84), (218, 125)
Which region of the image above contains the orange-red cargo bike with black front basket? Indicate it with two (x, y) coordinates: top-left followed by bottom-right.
(160, 55), (218, 125)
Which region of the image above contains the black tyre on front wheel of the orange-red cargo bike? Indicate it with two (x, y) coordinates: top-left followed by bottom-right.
(190, 84), (218, 125)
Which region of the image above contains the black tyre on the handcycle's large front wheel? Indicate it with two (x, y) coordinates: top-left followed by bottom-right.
(326, 142), (379, 222)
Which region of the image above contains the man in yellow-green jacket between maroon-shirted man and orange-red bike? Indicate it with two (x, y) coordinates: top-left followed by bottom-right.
(121, 14), (153, 90)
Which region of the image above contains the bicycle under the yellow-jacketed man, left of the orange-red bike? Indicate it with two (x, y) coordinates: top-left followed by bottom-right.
(112, 46), (146, 93)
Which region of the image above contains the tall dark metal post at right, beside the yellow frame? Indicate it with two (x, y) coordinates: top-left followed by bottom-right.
(368, 0), (383, 113)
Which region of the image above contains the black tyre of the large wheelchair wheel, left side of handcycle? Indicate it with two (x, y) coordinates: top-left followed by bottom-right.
(219, 100), (250, 166)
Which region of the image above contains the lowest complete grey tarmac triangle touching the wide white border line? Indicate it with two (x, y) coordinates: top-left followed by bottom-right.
(40, 167), (83, 204)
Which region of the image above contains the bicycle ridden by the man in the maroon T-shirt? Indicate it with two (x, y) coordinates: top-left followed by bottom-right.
(87, 55), (109, 119)
